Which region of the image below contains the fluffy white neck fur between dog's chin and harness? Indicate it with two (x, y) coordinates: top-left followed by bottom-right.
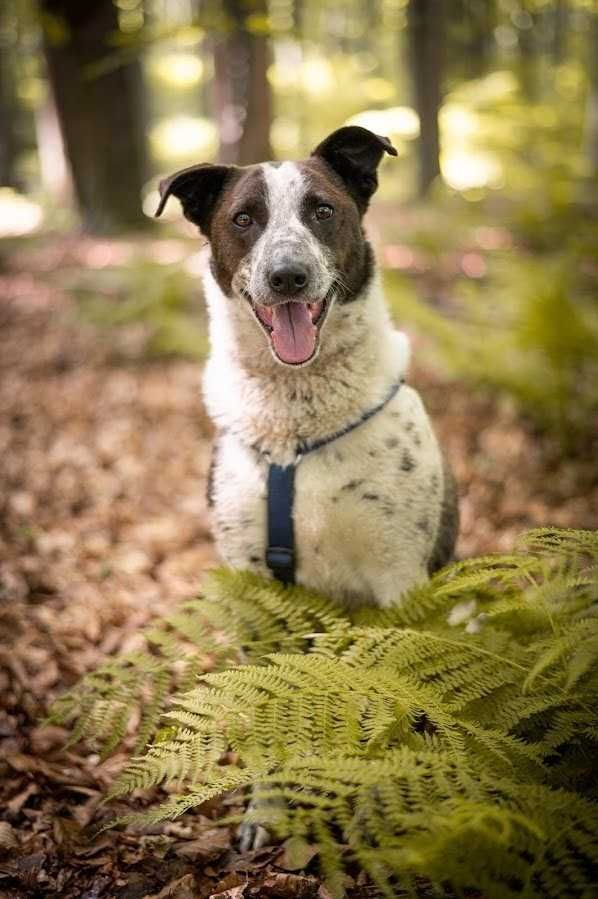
(204, 253), (409, 464)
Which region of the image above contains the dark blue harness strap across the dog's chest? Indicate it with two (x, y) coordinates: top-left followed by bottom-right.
(266, 378), (403, 584)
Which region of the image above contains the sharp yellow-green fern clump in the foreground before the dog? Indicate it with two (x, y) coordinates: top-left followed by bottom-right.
(55, 530), (598, 899)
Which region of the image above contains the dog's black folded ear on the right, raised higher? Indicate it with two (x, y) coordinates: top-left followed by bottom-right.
(311, 125), (397, 212)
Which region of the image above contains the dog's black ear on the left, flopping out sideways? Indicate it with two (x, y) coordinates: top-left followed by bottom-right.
(156, 162), (234, 234)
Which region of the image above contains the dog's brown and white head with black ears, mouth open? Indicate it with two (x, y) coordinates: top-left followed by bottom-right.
(156, 126), (396, 366)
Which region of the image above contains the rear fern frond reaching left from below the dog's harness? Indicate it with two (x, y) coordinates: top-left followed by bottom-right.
(49, 570), (349, 756)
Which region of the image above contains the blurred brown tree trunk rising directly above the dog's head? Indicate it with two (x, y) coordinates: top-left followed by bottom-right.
(214, 0), (272, 165)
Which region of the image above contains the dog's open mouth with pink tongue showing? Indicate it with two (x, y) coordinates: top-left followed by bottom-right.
(250, 296), (330, 365)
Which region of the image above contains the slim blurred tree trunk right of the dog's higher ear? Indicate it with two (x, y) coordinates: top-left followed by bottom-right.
(407, 0), (444, 196)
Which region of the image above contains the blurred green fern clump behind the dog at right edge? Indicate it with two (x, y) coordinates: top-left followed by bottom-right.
(389, 246), (598, 446)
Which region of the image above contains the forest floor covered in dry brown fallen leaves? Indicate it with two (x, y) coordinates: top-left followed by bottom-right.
(0, 239), (598, 899)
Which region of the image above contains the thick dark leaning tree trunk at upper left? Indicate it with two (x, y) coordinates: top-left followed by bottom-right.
(40, 0), (145, 233)
